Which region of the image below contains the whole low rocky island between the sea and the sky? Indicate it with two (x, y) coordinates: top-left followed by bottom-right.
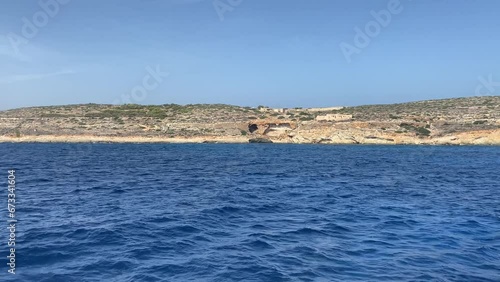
(0, 96), (500, 145)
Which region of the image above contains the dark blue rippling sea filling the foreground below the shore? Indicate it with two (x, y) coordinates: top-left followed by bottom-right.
(0, 144), (500, 282)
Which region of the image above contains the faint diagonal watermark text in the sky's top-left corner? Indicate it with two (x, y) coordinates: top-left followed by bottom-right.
(7, 0), (71, 55)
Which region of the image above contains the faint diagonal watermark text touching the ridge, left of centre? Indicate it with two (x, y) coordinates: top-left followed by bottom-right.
(113, 65), (170, 104)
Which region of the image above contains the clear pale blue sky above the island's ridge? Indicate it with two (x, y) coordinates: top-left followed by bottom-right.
(0, 0), (500, 109)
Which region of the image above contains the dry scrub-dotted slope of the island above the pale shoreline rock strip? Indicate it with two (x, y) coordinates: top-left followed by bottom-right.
(0, 96), (500, 143)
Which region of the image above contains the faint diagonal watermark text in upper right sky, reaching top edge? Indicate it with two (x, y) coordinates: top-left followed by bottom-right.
(339, 0), (412, 63)
